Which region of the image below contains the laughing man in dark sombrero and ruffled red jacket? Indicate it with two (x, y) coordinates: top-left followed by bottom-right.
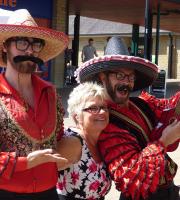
(76, 37), (180, 200)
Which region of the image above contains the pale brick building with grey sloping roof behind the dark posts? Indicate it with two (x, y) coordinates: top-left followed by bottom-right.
(69, 16), (180, 81)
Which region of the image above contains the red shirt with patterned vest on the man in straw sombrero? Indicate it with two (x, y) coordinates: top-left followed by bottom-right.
(0, 75), (64, 193)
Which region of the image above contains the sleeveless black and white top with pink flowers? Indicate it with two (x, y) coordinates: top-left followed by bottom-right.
(57, 129), (111, 200)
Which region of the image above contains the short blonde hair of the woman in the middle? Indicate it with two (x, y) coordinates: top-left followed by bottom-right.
(67, 82), (107, 122)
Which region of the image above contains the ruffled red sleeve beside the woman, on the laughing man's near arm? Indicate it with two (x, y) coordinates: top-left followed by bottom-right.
(98, 124), (165, 199)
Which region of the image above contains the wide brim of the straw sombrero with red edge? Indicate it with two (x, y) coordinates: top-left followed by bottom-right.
(0, 24), (69, 67)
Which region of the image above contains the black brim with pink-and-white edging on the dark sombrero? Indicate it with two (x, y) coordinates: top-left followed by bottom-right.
(76, 55), (158, 91)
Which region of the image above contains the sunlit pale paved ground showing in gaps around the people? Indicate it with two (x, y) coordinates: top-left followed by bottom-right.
(64, 118), (180, 200)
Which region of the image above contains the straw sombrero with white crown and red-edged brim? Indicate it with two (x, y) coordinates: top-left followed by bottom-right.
(0, 9), (68, 67)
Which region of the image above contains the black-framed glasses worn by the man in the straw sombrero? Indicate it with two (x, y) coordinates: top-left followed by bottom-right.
(6, 37), (45, 53)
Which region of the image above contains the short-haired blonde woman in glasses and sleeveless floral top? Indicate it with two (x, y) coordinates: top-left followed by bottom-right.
(57, 82), (111, 200)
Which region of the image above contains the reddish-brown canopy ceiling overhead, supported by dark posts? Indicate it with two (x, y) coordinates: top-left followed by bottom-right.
(69, 0), (180, 33)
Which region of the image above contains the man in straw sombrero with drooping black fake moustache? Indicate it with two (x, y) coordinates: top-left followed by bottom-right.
(0, 9), (68, 200)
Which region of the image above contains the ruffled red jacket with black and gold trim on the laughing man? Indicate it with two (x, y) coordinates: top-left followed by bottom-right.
(98, 93), (180, 199)
